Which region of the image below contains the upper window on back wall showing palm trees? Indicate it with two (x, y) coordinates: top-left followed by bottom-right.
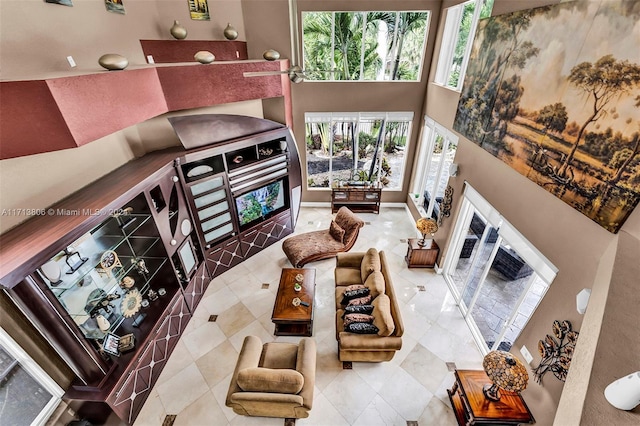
(302, 11), (429, 81)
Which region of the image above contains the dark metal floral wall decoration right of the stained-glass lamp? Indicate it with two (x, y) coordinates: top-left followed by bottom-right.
(533, 320), (579, 383)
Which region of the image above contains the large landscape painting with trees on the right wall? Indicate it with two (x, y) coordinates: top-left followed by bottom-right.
(454, 0), (640, 232)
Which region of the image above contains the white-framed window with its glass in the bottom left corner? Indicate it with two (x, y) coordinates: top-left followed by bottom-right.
(0, 328), (63, 425)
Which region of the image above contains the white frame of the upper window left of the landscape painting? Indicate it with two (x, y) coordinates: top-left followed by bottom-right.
(434, 0), (486, 92)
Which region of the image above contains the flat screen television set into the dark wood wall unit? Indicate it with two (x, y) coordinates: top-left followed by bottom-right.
(235, 179), (289, 229)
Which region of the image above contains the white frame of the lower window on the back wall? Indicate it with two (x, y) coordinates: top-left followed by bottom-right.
(304, 111), (414, 192)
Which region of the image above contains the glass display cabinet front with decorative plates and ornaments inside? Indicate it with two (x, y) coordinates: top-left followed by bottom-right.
(38, 194), (168, 339)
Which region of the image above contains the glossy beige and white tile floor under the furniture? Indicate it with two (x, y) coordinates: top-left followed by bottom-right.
(135, 207), (482, 426)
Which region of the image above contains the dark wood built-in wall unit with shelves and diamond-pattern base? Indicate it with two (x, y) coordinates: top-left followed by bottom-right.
(0, 115), (301, 424)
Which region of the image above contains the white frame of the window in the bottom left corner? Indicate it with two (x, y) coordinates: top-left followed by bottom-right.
(0, 327), (64, 425)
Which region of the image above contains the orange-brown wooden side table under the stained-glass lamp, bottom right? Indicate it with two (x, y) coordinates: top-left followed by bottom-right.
(447, 370), (535, 426)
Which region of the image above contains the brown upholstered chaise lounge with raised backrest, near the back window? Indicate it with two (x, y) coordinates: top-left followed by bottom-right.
(282, 207), (364, 268)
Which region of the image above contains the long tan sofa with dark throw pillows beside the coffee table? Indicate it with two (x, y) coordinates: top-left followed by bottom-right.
(335, 249), (404, 362)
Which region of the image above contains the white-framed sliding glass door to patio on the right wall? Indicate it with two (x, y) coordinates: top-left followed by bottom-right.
(444, 187), (556, 353)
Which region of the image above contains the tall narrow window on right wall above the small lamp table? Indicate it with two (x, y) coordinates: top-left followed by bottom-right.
(413, 117), (458, 218)
